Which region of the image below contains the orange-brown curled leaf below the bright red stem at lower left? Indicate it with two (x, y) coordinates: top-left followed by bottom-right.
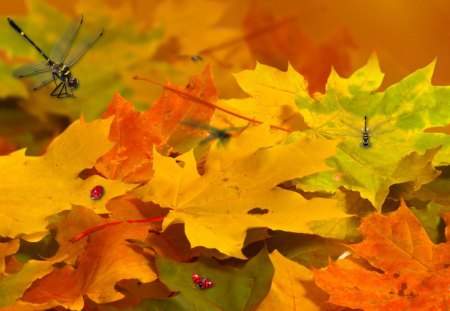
(21, 207), (156, 310)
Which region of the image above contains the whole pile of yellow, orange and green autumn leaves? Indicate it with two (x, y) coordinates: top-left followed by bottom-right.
(0, 59), (450, 310)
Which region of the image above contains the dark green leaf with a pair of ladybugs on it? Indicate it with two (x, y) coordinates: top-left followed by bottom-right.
(126, 250), (273, 310)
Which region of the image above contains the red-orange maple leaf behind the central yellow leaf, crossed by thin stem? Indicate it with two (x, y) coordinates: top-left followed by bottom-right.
(95, 66), (217, 183)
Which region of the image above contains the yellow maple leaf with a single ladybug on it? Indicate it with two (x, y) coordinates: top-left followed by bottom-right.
(0, 120), (134, 241)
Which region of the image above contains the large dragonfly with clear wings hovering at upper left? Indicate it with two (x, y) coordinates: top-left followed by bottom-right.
(7, 16), (103, 98)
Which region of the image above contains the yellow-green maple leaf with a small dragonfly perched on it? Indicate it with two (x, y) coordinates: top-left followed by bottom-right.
(297, 57), (450, 209)
